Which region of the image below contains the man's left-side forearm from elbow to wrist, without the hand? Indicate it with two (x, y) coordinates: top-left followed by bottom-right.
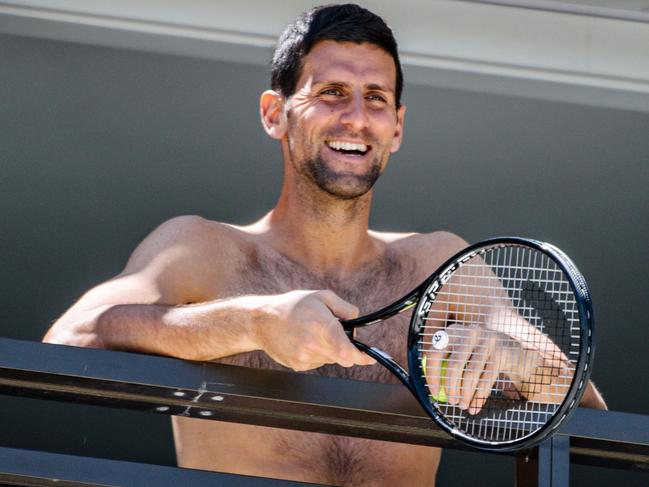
(44, 296), (263, 360)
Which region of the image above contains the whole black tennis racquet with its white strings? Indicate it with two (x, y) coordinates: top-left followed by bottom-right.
(341, 237), (594, 451)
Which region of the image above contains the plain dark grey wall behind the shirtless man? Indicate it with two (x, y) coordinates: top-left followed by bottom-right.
(0, 32), (649, 486)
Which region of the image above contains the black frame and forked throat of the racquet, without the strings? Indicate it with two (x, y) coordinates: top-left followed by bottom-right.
(341, 237), (595, 451)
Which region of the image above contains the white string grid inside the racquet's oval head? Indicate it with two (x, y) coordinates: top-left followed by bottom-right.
(419, 244), (581, 442)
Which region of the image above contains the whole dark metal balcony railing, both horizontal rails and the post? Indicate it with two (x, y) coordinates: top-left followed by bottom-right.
(0, 338), (649, 487)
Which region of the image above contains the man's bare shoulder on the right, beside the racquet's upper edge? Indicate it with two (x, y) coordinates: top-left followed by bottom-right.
(372, 231), (468, 269)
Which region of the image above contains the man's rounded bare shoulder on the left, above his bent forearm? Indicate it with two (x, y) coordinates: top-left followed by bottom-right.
(120, 215), (251, 301)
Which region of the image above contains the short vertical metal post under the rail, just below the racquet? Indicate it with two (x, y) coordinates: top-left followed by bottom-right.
(516, 435), (570, 487)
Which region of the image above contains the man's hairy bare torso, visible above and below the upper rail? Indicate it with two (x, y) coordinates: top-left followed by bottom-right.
(174, 227), (450, 486)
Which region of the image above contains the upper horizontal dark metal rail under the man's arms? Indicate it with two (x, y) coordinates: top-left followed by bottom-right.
(0, 338), (649, 471)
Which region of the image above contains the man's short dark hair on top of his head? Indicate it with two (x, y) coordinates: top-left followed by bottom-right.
(271, 3), (403, 108)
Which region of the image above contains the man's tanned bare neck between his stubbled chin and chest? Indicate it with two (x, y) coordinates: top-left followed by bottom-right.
(253, 183), (380, 276)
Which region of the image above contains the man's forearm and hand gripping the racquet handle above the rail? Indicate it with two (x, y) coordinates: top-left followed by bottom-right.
(44, 290), (375, 371)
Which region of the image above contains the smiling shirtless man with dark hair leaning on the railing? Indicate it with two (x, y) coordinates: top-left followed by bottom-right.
(45, 6), (604, 486)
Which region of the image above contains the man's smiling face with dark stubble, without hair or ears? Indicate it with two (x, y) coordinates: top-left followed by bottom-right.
(287, 41), (405, 199)
